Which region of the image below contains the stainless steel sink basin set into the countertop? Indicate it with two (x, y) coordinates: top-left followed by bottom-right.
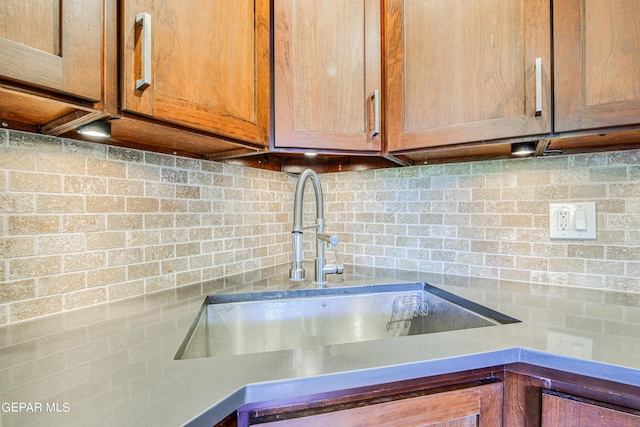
(175, 282), (518, 359)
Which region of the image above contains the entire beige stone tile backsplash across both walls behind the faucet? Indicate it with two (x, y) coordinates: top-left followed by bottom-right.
(0, 130), (640, 324)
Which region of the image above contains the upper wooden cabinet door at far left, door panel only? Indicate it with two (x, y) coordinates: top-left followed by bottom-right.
(0, 0), (104, 101)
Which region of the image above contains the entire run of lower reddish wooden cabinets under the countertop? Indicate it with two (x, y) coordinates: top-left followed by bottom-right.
(216, 363), (640, 427)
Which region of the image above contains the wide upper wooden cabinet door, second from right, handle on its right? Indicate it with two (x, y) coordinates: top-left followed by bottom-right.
(385, 0), (551, 151)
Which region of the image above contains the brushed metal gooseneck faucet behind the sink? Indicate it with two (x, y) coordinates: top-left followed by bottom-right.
(289, 169), (344, 286)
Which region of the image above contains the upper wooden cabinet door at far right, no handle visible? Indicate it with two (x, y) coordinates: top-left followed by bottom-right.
(553, 0), (640, 132)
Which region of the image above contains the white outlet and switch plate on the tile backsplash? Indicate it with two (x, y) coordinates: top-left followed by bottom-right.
(549, 202), (596, 240)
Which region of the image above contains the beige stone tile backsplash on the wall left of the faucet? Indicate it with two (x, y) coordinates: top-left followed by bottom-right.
(0, 131), (295, 324)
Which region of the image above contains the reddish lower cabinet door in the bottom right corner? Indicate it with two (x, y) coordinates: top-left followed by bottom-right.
(541, 390), (640, 427)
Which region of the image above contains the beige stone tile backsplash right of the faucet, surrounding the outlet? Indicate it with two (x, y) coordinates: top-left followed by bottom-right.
(322, 151), (640, 292)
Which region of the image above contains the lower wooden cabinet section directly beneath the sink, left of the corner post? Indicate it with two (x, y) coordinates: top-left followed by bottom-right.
(232, 368), (503, 427)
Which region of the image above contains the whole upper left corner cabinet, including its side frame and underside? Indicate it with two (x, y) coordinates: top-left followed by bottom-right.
(0, 0), (115, 135)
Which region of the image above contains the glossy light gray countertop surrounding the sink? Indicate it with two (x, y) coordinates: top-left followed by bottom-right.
(0, 265), (640, 427)
